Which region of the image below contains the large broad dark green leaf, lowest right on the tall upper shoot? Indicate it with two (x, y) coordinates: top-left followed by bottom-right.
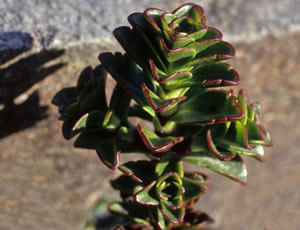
(170, 90), (243, 124)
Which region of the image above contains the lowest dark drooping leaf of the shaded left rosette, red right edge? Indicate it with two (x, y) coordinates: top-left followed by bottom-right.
(96, 138), (120, 170)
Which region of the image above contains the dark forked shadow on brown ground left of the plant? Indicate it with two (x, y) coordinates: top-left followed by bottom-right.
(0, 50), (65, 138)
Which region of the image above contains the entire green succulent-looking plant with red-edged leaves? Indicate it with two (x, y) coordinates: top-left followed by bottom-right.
(53, 4), (271, 229)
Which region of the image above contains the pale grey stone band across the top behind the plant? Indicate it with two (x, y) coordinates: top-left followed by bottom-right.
(0, 0), (300, 52)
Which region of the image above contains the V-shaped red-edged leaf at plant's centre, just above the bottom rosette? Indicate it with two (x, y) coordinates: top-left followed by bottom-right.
(137, 125), (184, 153)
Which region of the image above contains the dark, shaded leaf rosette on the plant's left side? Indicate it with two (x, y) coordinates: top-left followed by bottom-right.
(52, 65), (130, 168)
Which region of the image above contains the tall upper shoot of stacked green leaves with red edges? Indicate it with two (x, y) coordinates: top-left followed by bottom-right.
(99, 4), (242, 136)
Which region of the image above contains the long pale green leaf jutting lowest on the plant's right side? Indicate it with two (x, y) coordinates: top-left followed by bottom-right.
(182, 152), (247, 184)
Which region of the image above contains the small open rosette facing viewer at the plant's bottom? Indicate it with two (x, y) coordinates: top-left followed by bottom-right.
(110, 153), (207, 229)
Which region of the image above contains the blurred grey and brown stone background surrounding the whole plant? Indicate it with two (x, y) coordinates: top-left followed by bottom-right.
(0, 0), (300, 230)
